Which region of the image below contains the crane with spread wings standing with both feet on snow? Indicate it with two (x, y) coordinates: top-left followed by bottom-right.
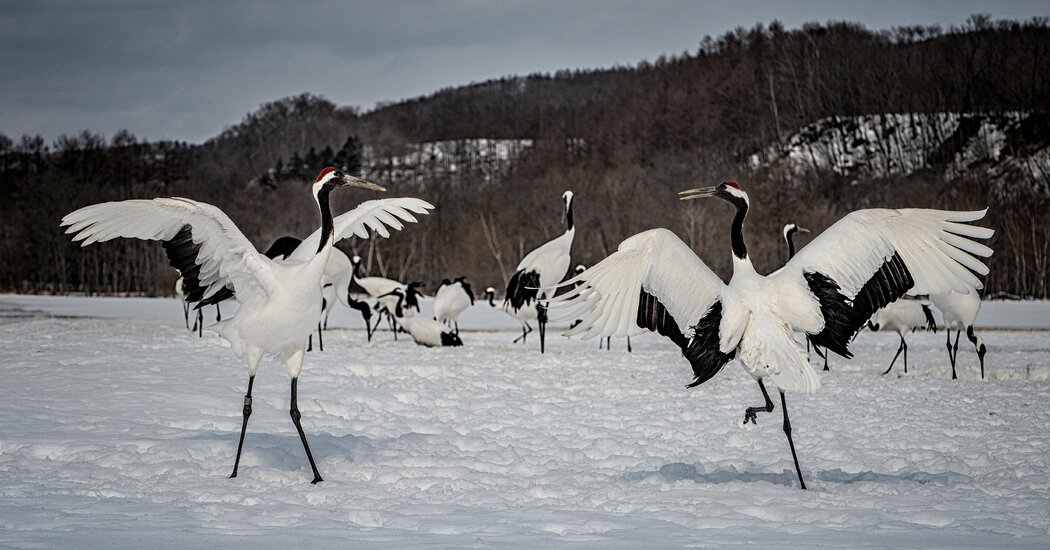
(62, 167), (434, 483)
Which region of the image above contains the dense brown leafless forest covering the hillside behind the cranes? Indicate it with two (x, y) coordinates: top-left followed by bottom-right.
(6, 16), (1050, 298)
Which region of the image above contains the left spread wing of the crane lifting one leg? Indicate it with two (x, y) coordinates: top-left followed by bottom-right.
(553, 229), (734, 386)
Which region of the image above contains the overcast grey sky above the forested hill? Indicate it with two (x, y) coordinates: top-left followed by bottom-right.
(0, 0), (1050, 143)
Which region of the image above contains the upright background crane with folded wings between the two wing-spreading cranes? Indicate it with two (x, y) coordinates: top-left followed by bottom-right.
(505, 191), (576, 354)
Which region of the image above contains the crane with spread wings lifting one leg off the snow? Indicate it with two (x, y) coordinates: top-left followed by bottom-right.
(558, 182), (992, 489)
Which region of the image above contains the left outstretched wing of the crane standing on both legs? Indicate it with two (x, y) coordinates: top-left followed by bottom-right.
(60, 198), (276, 302)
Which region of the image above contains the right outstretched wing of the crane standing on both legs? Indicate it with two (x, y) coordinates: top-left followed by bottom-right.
(288, 197), (434, 262)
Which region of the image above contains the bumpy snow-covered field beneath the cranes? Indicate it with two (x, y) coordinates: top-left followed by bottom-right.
(0, 295), (1050, 549)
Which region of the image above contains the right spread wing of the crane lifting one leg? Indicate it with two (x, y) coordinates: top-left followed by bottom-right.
(770, 209), (994, 357)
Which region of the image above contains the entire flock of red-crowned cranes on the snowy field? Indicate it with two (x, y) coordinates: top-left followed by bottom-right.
(62, 172), (992, 489)
